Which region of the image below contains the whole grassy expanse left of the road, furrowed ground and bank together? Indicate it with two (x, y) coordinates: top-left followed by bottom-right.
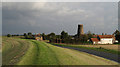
(2, 37), (118, 65)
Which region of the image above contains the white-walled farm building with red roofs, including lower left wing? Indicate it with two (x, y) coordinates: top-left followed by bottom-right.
(90, 35), (116, 44)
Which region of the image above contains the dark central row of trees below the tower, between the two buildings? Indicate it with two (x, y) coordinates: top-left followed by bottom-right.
(42, 31), (94, 44)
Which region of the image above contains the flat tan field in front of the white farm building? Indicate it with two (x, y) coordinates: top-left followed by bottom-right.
(77, 45), (120, 51)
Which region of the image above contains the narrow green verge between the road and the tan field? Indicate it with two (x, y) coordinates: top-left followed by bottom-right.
(53, 44), (120, 55)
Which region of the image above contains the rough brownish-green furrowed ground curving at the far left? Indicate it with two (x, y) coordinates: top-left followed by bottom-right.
(2, 37), (30, 65)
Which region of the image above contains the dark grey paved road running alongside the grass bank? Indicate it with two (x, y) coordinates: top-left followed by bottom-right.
(53, 45), (120, 63)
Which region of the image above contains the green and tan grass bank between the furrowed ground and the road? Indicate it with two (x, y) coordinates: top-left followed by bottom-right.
(15, 40), (116, 65)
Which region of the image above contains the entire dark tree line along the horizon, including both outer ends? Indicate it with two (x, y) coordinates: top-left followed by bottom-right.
(7, 30), (120, 44)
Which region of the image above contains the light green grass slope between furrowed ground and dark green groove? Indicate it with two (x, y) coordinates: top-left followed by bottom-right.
(17, 42), (37, 65)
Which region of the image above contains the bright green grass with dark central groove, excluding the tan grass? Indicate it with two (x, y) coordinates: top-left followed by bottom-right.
(18, 40), (58, 65)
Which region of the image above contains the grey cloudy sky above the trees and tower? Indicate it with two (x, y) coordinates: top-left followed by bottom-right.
(2, 2), (118, 35)
